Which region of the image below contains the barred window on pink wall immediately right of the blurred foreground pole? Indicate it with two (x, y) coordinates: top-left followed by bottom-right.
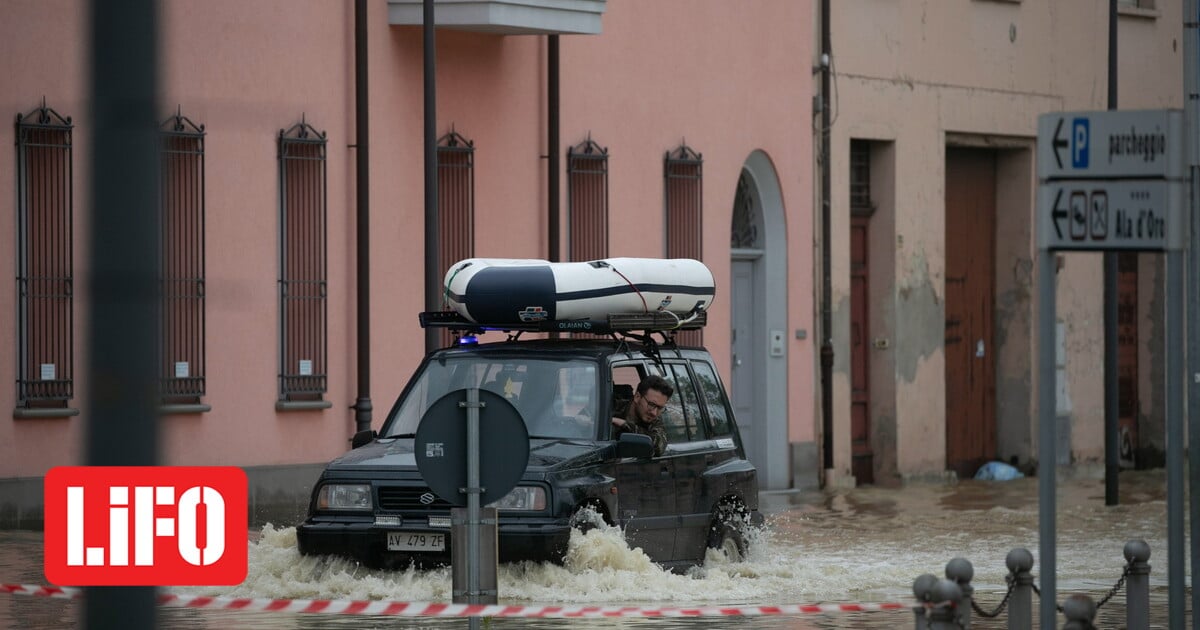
(158, 112), (205, 406)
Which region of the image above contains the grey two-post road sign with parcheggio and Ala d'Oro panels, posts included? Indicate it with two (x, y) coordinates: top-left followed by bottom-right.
(1034, 109), (1194, 629)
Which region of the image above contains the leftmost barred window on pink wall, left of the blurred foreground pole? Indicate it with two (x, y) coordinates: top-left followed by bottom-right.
(14, 101), (74, 418)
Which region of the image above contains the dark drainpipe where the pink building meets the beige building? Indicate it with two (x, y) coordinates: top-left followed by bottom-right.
(821, 0), (833, 475)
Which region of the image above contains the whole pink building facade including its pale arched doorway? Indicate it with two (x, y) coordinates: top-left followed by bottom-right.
(0, 0), (820, 527)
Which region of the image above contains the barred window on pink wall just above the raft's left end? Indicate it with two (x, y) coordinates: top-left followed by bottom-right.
(566, 136), (608, 262)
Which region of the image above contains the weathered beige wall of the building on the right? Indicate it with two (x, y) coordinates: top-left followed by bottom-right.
(832, 0), (1182, 478)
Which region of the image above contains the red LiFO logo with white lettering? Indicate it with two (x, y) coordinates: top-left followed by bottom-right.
(43, 466), (247, 586)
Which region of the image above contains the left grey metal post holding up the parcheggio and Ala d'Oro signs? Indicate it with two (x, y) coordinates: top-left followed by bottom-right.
(1037, 250), (1058, 630)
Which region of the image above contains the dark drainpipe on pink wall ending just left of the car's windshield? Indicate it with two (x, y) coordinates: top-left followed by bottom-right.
(354, 0), (371, 431)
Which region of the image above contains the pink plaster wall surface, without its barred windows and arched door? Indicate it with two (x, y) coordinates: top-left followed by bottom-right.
(0, 0), (816, 525)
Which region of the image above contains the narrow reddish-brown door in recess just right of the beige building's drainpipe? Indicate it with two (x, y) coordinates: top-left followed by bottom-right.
(850, 216), (875, 484)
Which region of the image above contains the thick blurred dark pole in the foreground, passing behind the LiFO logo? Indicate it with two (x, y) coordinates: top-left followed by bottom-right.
(84, 0), (161, 630)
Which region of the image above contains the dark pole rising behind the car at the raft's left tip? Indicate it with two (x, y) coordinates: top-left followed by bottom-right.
(421, 0), (444, 352)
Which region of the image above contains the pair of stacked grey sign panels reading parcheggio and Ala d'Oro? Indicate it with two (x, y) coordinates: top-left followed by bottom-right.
(1037, 109), (1188, 251)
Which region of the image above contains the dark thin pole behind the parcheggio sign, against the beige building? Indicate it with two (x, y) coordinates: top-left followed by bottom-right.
(1104, 0), (1121, 505)
